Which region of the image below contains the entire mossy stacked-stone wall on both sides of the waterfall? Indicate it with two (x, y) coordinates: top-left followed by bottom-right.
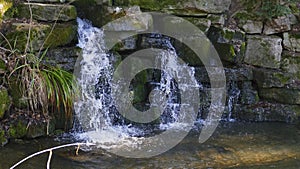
(0, 0), (300, 143)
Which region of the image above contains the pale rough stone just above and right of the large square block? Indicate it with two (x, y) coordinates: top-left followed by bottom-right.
(263, 15), (296, 35)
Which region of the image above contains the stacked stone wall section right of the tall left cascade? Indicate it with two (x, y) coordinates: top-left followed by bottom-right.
(83, 0), (300, 122)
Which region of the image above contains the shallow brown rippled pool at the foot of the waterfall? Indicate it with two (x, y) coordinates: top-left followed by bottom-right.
(0, 123), (300, 169)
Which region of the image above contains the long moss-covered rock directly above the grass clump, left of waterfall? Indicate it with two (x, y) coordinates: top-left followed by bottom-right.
(6, 23), (77, 51)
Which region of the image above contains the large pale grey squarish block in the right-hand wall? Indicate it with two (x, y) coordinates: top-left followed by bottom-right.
(244, 35), (282, 68)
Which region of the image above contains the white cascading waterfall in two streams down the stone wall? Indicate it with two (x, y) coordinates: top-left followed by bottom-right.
(75, 19), (201, 151)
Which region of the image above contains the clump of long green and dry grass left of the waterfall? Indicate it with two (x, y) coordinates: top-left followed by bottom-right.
(0, 0), (78, 124)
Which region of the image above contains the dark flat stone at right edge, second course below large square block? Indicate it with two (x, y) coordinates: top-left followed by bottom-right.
(259, 88), (300, 104)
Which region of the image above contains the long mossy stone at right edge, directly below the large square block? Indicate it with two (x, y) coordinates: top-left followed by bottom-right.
(253, 68), (300, 89)
